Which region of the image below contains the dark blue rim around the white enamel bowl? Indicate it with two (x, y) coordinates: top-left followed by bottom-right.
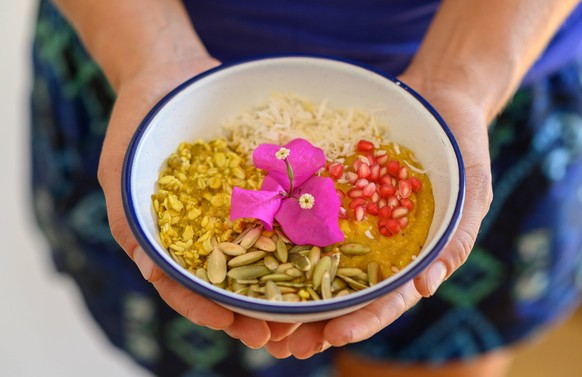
(121, 54), (465, 315)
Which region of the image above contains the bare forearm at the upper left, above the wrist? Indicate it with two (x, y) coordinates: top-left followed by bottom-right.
(53, 0), (206, 89)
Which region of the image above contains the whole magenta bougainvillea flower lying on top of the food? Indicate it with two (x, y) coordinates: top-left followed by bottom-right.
(230, 139), (344, 246)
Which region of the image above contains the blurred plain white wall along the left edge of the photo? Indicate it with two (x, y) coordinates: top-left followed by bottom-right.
(0, 0), (148, 377)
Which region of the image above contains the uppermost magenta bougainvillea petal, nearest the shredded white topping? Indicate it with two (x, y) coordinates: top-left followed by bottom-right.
(253, 139), (326, 190)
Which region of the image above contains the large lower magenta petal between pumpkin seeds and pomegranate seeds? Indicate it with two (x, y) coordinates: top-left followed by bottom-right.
(275, 176), (344, 246)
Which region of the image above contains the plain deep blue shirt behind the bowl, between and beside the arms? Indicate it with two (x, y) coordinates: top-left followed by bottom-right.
(184, 0), (582, 82)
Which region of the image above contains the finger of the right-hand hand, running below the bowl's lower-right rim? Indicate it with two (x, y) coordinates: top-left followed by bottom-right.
(326, 281), (421, 347)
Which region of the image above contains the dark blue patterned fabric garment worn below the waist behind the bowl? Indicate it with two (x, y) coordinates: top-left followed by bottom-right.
(31, 1), (582, 377)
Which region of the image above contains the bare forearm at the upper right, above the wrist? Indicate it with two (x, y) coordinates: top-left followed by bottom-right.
(407, 0), (578, 122)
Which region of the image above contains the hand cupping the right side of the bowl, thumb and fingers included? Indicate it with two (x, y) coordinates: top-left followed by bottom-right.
(266, 74), (492, 358)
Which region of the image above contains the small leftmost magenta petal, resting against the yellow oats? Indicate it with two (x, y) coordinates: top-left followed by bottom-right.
(230, 187), (282, 230)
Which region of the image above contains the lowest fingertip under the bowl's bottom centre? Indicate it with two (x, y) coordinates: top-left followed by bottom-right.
(287, 321), (329, 359)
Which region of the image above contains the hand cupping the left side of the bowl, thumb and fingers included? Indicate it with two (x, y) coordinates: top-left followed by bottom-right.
(99, 55), (298, 347)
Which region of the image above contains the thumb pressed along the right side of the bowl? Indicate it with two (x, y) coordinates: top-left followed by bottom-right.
(414, 158), (492, 297)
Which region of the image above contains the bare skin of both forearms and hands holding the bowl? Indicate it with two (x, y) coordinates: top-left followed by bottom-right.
(54, 0), (577, 375)
